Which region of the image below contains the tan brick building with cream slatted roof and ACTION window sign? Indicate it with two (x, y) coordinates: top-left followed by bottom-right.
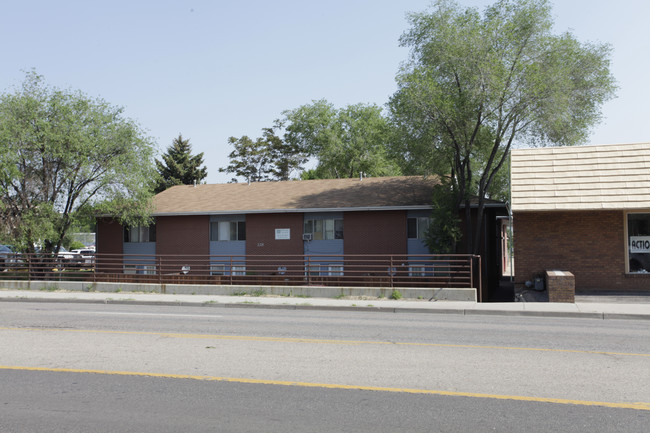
(511, 143), (650, 292)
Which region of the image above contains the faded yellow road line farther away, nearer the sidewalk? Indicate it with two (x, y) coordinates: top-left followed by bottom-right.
(0, 327), (650, 357)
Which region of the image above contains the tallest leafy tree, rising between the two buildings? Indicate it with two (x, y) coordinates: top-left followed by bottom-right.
(389, 0), (615, 253)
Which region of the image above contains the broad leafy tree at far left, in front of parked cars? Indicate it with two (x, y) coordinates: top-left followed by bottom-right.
(0, 72), (155, 252)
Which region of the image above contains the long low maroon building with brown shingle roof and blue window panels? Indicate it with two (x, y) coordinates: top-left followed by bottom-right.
(97, 176), (437, 274)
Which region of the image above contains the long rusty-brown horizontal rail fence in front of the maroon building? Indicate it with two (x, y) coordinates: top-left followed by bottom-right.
(0, 253), (480, 290)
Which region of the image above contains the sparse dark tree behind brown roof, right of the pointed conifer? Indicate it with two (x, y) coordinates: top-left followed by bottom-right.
(219, 125), (307, 182)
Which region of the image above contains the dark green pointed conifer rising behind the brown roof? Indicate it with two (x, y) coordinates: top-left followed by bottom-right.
(155, 134), (208, 194)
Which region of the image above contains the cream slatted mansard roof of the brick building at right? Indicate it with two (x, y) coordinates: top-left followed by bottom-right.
(511, 143), (650, 211)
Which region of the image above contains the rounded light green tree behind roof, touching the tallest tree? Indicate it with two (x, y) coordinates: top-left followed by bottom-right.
(282, 100), (400, 178)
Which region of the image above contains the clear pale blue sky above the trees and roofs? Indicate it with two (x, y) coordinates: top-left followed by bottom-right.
(0, 0), (650, 183)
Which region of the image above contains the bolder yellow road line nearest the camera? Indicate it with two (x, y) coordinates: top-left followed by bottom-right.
(0, 365), (650, 411)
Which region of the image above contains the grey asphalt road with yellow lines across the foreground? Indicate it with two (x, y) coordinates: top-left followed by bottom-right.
(0, 302), (650, 432)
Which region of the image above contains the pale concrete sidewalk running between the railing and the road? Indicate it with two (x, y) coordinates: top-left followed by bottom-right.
(0, 289), (650, 320)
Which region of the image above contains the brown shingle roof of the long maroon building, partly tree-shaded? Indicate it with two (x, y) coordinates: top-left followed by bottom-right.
(154, 176), (438, 215)
